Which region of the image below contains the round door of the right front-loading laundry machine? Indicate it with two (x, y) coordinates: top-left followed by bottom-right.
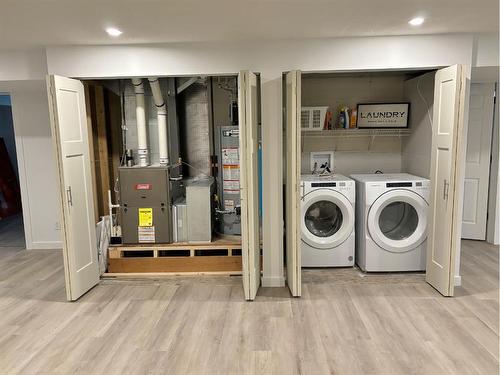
(367, 189), (429, 253)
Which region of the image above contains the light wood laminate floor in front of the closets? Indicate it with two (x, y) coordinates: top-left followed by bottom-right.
(0, 241), (499, 375)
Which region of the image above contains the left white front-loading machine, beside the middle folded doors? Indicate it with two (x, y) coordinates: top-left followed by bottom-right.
(301, 174), (356, 267)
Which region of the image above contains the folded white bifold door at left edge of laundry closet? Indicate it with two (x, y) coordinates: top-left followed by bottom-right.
(285, 70), (302, 297)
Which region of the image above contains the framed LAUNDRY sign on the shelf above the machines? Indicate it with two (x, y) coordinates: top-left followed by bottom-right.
(357, 103), (410, 129)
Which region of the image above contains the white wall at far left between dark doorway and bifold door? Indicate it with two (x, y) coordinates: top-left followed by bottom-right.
(0, 80), (61, 249)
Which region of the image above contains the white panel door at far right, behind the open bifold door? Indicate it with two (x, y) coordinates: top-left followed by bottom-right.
(462, 83), (495, 240)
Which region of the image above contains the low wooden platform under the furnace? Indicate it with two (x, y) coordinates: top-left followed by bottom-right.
(108, 239), (246, 274)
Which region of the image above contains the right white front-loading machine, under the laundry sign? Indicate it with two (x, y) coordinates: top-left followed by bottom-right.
(351, 173), (430, 272)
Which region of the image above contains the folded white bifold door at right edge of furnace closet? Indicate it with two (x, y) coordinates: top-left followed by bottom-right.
(238, 71), (260, 300)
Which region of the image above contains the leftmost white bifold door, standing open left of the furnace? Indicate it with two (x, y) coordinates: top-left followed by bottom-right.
(47, 75), (99, 301)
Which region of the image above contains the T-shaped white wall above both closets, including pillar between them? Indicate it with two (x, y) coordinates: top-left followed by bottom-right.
(46, 34), (473, 286)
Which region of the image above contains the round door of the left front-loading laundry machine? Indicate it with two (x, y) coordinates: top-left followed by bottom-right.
(301, 189), (354, 249)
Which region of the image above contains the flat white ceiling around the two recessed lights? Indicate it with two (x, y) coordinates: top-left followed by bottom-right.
(0, 0), (499, 53)
